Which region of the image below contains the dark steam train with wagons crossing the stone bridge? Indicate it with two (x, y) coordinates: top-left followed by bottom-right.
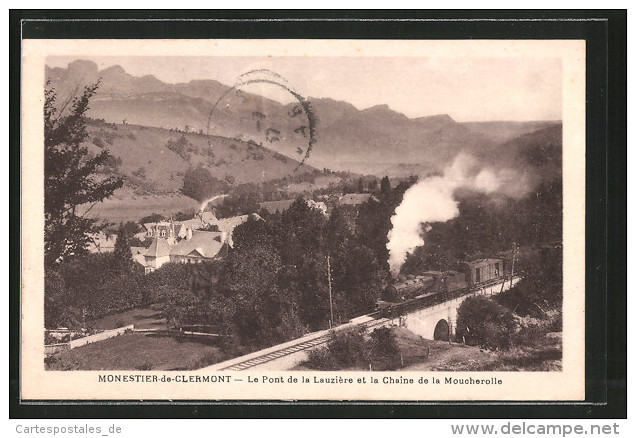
(376, 259), (504, 311)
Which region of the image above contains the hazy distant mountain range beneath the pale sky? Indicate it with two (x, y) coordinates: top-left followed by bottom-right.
(46, 60), (560, 176)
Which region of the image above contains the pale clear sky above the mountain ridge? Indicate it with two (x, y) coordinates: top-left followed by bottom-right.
(46, 56), (562, 122)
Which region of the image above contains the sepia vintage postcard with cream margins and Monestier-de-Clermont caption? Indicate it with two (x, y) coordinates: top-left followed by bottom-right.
(20, 40), (586, 401)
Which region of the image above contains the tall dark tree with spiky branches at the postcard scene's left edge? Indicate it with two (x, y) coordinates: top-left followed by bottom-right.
(44, 83), (123, 265)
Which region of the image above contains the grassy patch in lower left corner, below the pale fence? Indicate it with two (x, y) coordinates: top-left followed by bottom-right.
(47, 333), (224, 370)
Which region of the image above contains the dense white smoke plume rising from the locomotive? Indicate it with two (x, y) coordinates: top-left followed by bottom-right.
(386, 154), (501, 275)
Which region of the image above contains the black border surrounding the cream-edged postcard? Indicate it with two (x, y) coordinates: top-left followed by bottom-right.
(9, 10), (627, 419)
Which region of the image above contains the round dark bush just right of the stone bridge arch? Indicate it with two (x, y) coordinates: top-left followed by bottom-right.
(457, 297), (515, 350)
